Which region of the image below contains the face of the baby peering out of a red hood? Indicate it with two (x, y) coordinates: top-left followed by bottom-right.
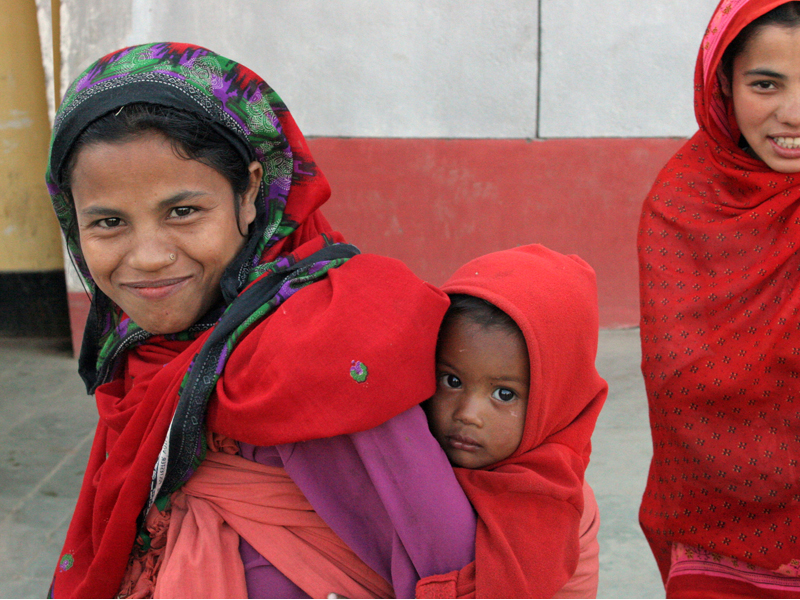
(427, 317), (530, 469)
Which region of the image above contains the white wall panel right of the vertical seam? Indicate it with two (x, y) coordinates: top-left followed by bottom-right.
(539, 0), (718, 138)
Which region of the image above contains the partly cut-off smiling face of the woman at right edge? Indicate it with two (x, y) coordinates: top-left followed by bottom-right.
(723, 25), (800, 173)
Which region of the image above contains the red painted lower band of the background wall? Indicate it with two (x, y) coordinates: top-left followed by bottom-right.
(70, 138), (683, 348)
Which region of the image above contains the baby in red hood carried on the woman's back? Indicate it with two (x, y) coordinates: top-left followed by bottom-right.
(417, 245), (607, 598)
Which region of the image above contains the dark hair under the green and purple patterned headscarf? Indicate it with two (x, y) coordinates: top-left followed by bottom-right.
(61, 102), (255, 246)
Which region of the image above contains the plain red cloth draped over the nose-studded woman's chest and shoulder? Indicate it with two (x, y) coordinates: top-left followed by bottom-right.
(55, 255), (447, 597)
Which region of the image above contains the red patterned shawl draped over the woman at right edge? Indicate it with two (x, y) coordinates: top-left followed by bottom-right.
(638, 0), (800, 579)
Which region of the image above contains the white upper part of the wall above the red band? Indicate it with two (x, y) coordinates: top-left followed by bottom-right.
(62, 0), (716, 138)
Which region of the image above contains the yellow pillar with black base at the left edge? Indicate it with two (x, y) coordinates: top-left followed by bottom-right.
(0, 0), (66, 335)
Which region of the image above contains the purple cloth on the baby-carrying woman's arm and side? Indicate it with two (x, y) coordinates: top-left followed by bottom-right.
(239, 406), (476, 598)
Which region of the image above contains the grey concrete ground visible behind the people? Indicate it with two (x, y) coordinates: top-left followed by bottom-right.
(0, 329), (664, 598)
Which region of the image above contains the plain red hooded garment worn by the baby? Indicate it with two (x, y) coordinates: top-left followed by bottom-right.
(417, 245), (608, 598)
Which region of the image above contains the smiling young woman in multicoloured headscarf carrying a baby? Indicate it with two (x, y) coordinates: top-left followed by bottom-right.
(47, 43), (475, 598)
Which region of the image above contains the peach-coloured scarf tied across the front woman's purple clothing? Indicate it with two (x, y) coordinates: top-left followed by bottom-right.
(119, 438), (394, 598)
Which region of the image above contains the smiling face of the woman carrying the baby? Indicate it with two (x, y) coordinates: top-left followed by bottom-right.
(71, 133), (262, 334)
